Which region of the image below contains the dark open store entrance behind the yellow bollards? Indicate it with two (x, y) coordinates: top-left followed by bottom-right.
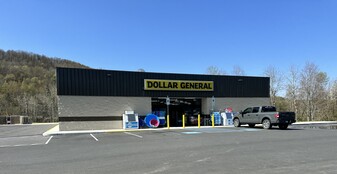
(152, 98), (201, 127)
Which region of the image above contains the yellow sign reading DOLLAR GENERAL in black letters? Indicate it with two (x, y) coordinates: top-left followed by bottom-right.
(144, 79), (214, 91)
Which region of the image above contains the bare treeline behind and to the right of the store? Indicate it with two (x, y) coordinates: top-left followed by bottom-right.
(206, 62), (337, 121)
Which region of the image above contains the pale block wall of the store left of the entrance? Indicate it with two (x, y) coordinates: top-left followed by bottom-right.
(58, 96), (152, 130)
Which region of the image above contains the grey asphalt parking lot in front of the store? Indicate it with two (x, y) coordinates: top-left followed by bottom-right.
(0, 126), (337, 174)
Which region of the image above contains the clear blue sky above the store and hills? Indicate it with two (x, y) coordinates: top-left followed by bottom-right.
(0, 0), (337, 79)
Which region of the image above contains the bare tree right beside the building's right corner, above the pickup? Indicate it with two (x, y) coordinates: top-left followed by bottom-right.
(264, 66), (283, 105)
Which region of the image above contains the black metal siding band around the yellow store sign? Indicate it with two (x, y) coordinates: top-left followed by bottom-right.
(57, 68), (269, 97)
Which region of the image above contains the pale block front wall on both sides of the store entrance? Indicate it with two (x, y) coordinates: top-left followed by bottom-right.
(58, 96), (270, 131)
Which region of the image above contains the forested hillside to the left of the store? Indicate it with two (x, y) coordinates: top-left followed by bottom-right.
(0, 49), (88, 122)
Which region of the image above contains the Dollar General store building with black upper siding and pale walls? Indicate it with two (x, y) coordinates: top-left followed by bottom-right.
(57, 68), (270, 130)
